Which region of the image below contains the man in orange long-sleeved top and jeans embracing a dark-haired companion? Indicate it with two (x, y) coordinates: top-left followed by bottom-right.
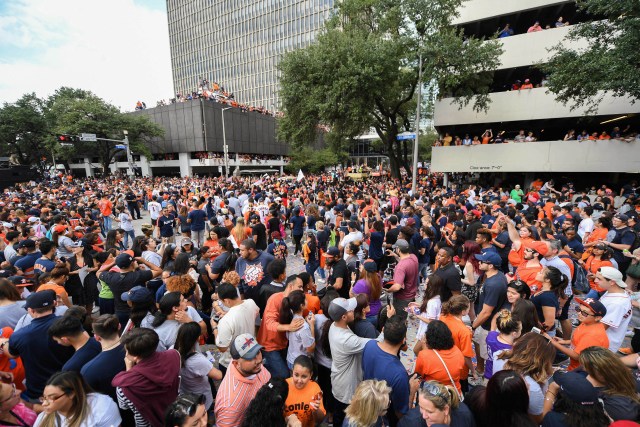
(258, 278), (305, 378)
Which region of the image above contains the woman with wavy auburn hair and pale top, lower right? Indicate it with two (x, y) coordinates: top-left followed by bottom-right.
(493, 332), (556, 424)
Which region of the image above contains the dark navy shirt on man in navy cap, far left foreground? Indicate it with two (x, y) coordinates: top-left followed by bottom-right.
(9, 314), (73, 399)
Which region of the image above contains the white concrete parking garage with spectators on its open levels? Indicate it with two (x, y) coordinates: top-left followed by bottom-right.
(431, 0), (640, 177)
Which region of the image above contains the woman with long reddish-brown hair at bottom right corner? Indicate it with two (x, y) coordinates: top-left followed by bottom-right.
(579, 346), (640, 421)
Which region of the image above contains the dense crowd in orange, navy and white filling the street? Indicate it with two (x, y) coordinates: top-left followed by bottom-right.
(0, 174), (640, 427)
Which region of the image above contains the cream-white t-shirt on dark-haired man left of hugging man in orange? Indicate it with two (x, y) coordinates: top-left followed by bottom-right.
(216, 299), (260, 368)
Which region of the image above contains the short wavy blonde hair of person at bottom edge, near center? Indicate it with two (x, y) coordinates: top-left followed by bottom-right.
(343, 380), (391, 427)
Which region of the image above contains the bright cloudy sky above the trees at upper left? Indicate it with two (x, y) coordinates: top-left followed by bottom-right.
(0, 0), (173, 111)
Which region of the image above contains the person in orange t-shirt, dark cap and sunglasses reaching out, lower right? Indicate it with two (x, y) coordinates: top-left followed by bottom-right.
(544, 298), (609, 371)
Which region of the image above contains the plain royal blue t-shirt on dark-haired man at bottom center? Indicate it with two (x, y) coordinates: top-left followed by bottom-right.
(362, 340), (409, 425)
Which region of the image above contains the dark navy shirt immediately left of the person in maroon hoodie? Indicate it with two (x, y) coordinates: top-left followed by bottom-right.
(80, 344), (125, 400)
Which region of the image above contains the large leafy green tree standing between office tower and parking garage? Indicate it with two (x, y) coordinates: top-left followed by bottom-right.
(279, 0), (501, 177)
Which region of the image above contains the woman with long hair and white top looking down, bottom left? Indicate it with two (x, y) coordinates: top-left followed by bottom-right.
(34, 371), (122, 427)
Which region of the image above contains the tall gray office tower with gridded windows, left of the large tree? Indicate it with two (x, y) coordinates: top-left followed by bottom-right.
(167, 0), (334, 110)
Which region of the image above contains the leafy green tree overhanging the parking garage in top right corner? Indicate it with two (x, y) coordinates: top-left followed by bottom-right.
(542, 0), (640, 111)
